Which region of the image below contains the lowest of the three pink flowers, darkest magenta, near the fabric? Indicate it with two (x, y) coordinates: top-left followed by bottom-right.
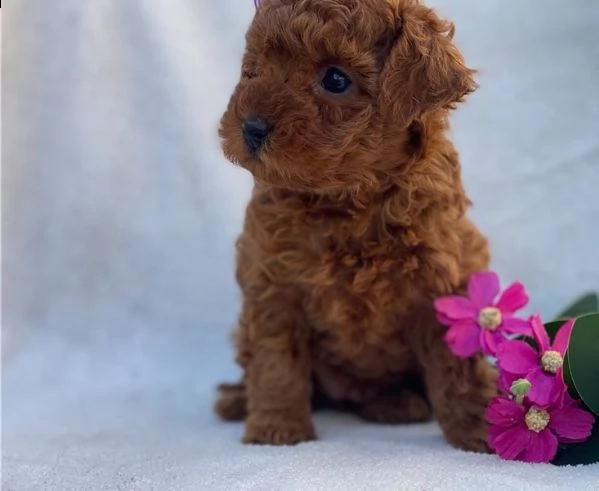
(486, 386), (594, 462)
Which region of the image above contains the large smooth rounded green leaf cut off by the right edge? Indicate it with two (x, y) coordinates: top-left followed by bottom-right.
(567, 312), (599, 415)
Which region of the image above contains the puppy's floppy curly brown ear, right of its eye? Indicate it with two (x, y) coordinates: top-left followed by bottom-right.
(380, 0), (476, 125)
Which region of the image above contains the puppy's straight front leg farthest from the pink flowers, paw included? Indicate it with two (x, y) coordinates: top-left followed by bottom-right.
(243, 297), (316, 445)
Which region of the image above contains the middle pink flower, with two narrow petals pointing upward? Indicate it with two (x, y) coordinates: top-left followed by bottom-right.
(497, 315), (574, 407)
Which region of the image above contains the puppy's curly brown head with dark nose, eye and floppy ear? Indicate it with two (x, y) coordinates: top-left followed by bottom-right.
(219, 0), (475, 192)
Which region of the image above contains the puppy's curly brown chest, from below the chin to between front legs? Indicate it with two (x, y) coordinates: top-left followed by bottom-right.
(248, 200), (417, 377)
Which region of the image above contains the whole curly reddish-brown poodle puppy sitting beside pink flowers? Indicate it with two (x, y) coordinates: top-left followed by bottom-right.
(216, 0), (495, 451)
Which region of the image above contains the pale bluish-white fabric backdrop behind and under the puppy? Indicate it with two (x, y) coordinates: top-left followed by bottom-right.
(2, 0), (599, 490)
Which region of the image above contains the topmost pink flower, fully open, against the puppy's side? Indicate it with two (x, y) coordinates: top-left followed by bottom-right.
(435, 272), (531, 358)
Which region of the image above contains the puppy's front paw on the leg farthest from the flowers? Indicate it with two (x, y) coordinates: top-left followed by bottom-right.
(243, 417), (316, 445)
